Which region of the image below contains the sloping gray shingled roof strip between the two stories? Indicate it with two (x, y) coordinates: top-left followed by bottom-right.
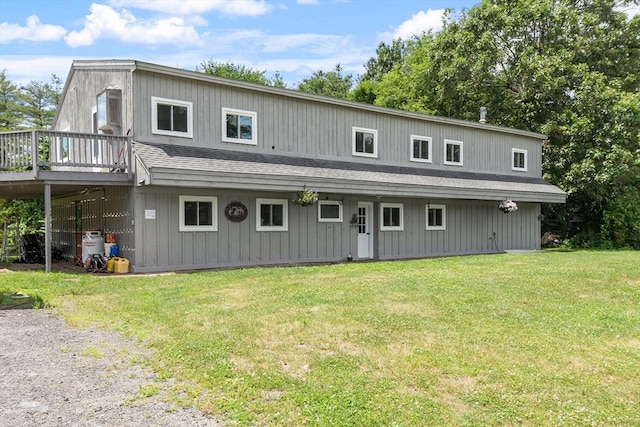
(134, 142), (566, 202)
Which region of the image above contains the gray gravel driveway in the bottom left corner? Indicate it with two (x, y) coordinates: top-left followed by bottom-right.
(0, 309), (220, 427)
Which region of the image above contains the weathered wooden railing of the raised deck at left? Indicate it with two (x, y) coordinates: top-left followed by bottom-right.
(0, 130), (131, 174)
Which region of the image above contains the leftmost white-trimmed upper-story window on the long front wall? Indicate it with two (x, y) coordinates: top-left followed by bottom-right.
(151, 96), (193, 138)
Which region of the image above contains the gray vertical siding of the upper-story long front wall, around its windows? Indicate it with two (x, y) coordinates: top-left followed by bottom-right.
(133, 71), (542, 177)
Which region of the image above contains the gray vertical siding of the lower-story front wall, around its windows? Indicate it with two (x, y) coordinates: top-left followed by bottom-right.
(134, 187), (540, 272)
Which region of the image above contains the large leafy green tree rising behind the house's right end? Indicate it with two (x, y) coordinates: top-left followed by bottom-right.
(356, 0), (640, 246)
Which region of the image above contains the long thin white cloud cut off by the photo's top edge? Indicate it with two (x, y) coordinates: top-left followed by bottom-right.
(108, 0), (271, 16)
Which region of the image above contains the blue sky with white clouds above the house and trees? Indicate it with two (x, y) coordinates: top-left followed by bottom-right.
(0, 0), (476, 86)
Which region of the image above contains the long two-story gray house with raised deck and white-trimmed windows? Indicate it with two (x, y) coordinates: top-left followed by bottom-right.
(0, 60), (566, 272)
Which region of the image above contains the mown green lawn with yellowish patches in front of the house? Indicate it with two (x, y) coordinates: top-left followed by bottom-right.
(0, 251), (640, 426)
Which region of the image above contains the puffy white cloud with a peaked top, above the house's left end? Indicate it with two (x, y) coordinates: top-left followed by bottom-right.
(65, 3), (202, 47)
